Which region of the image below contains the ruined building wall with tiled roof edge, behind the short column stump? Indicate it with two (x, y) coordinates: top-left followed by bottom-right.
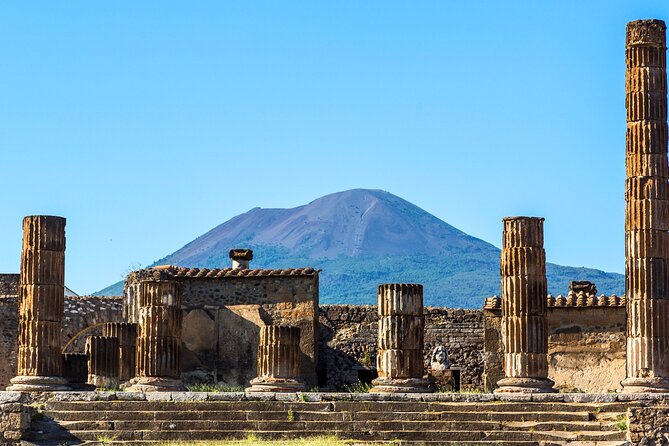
(124, 267), (318, 387)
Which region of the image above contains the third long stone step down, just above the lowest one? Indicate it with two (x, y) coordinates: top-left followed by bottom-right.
(44, 414), (617, 432)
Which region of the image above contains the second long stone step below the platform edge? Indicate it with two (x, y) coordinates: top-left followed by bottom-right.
(43, 408), (596, 422)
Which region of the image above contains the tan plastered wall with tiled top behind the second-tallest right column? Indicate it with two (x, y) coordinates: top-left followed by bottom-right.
(483, 296), (627, 392)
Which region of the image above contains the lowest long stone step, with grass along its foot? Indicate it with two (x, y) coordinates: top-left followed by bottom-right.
(26, 429), (625, 444)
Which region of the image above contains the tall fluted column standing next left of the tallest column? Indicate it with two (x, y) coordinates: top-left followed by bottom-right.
(495, 217), (555, 393)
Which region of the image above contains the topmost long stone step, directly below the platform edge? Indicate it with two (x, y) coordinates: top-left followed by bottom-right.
(46, 401), (627, 413)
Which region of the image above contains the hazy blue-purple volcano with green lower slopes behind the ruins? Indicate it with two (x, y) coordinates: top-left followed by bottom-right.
(96, 189), (624, 308)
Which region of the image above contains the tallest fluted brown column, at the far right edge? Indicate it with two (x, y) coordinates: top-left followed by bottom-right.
(621, 20), (669, 393)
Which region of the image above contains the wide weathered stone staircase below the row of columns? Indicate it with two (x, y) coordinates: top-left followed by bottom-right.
(23, 392), (627, 445)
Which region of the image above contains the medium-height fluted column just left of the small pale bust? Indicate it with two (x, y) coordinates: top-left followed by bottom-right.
(370, 283), (433, 393)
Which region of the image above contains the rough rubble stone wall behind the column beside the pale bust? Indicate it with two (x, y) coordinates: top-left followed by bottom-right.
(319, 305), (483, 389)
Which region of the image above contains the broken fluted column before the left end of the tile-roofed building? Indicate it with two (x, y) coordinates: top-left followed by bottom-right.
(128, 278), (184, 392)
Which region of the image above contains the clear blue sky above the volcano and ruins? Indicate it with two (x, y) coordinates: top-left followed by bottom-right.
(0, 0), (669, 293)
